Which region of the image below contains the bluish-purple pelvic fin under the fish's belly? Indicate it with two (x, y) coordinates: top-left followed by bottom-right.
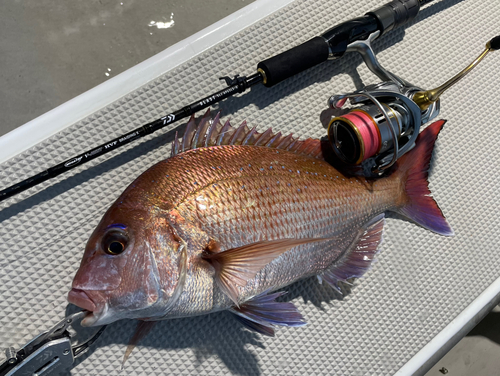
(230, 291), (307, 337)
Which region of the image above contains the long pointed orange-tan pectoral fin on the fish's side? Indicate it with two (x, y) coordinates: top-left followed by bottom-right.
(203, 238), (328, 305)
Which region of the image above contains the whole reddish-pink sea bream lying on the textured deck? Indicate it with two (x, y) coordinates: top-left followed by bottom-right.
(69, 113), (451, 334)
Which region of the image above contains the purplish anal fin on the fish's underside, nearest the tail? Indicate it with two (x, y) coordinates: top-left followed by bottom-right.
(318, 214), (385, 293)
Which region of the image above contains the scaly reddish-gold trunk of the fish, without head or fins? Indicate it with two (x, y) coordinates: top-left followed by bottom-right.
(145, 145), (398, 315)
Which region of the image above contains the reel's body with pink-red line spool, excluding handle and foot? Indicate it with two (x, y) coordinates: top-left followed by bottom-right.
(328, 81), (439, 175)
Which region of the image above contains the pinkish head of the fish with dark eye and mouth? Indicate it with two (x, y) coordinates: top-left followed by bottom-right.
(68, 203), (186, 326)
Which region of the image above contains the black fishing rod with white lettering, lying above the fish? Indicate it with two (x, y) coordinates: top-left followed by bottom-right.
(0, 0), (433, 201)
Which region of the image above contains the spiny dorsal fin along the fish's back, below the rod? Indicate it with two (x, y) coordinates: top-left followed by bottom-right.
(171, 110), (324, 160)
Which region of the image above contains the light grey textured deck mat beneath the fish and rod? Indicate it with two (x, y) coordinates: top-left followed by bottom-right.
(0, 0), (500, 376)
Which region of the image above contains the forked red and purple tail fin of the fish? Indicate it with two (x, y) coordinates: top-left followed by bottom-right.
(395, 120), (453, 236)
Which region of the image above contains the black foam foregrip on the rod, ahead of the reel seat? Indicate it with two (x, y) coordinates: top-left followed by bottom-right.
(257, 37), (329, 87)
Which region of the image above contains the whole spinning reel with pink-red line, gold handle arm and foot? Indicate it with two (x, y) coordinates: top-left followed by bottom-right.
(328, 31), (500, 176)
